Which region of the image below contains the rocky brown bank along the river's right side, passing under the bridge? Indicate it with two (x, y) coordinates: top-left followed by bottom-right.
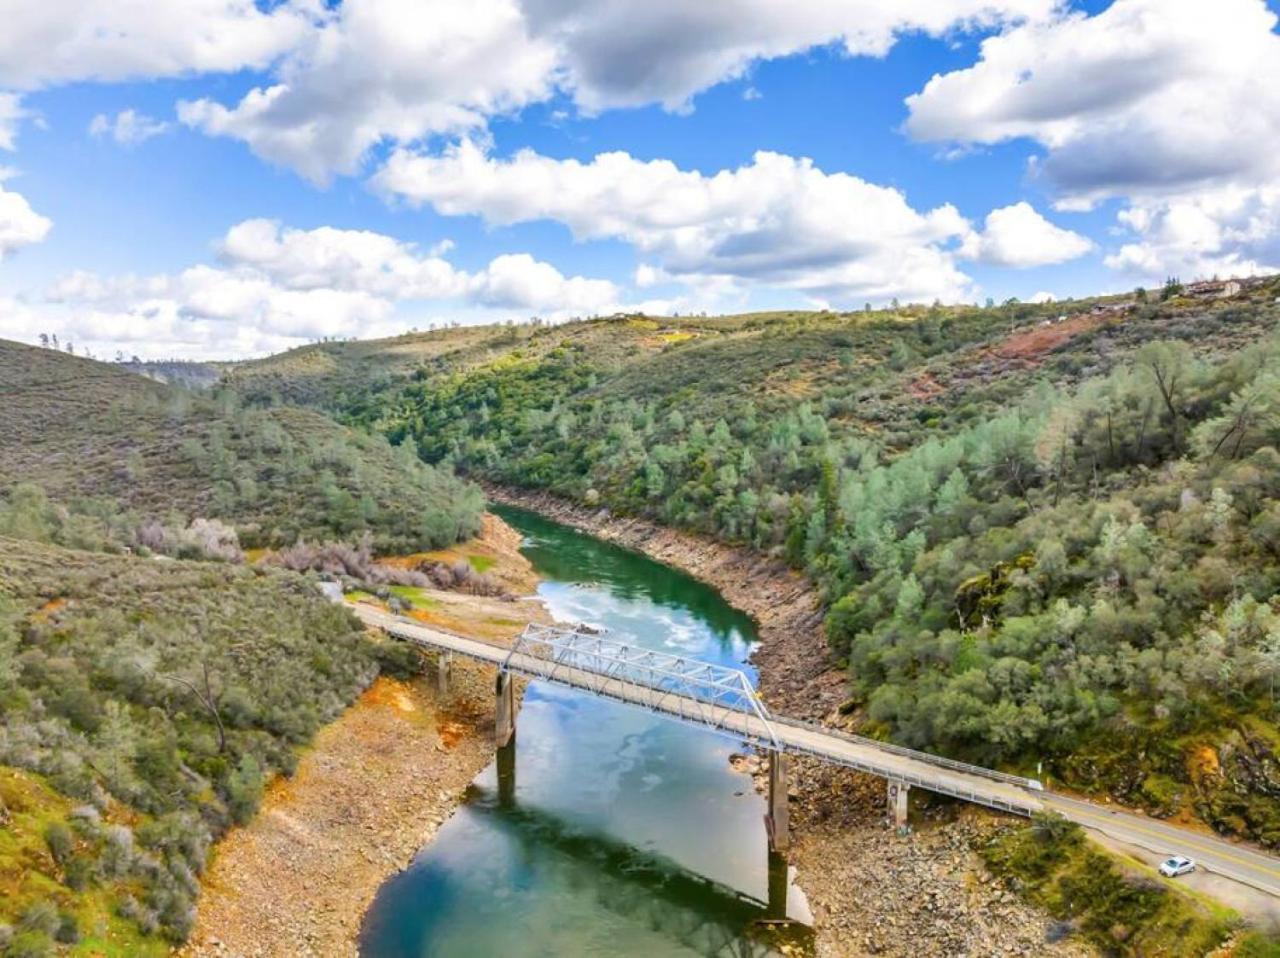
(486, 487), (1092, 958)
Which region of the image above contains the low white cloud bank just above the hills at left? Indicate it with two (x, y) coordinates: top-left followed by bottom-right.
(28, 219), (618, 356)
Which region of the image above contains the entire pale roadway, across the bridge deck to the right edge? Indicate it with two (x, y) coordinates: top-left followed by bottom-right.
(355, 606), (1280, 898)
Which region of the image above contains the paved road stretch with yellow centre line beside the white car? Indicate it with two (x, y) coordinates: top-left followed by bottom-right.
(1042, 792), (1280, 898)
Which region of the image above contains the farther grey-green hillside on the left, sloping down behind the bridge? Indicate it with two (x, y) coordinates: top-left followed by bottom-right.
(0, 341), (483, 557)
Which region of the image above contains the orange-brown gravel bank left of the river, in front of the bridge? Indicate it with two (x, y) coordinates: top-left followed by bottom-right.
(180, 662), (493, 958)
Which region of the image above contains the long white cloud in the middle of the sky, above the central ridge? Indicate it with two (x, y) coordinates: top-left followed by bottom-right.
(374, 142), (970, 301)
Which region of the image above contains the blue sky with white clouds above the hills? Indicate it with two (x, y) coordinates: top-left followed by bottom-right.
(0, 0), (1280, 359)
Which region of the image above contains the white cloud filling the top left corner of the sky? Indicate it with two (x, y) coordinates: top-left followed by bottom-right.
(0, 0), (317, 90)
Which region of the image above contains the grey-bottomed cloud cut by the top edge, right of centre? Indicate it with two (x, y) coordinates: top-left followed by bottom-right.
(524, 0), (1056, 111)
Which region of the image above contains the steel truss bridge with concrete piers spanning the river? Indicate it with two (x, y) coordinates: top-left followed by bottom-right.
(356, 606), (1046, 848)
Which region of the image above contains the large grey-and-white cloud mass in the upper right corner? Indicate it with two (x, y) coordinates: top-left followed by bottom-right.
(906, 0), (1280, 279)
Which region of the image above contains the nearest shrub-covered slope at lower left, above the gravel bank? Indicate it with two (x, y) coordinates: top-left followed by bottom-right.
(0, 538), (404, 955)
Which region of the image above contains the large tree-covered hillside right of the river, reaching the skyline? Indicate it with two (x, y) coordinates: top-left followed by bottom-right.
(227, 277), (1280, 845)
